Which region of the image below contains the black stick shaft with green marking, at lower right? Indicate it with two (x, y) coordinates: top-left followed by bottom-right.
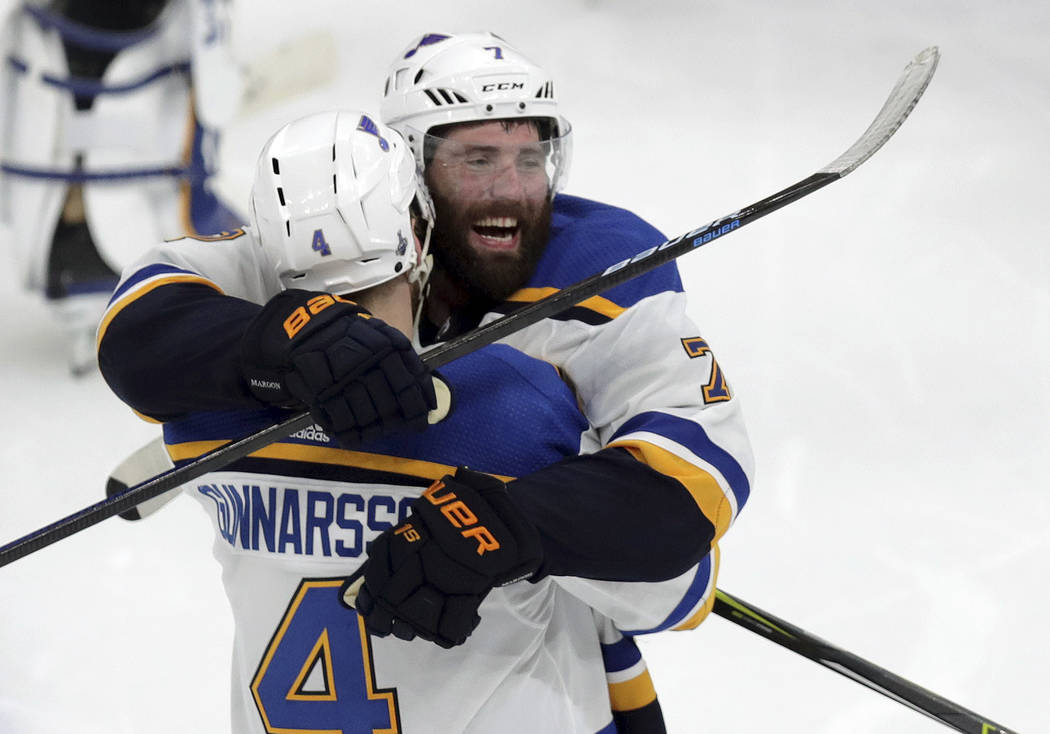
(714, 589), (1015, 734)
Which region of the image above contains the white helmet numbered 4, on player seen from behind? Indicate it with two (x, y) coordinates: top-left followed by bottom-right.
(250, 110), (431, 293)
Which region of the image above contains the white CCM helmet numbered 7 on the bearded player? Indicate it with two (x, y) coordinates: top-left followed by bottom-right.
(380, 33), (572, 195)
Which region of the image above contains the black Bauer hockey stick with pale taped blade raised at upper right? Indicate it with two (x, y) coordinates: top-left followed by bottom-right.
(0, 46), (940, 566)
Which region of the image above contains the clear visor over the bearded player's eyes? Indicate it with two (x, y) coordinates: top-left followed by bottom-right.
(423, 121), (572, 196)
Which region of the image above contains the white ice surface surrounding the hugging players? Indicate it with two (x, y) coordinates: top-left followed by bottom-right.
(0, 0), (1050, 734)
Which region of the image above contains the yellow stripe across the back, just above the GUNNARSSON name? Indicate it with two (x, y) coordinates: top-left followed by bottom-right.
(167, 441), (513, 482)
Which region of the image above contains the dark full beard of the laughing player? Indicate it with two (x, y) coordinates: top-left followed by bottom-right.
(431, 192), (551, 301)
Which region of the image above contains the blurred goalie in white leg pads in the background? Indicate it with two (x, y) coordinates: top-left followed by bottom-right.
(0, 0), (244, 374)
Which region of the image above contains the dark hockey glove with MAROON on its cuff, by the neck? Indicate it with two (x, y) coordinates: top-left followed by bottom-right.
(240, 290), (437, 447)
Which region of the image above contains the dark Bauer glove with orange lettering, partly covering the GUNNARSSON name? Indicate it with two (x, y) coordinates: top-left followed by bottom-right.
(342, 467), (542, 648)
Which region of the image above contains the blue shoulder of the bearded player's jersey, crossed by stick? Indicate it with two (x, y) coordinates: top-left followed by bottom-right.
(528, 194), (681, 308)
